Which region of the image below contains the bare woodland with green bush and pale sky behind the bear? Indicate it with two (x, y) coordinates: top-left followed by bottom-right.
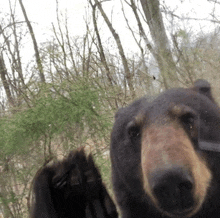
(0, 0), (220, 218)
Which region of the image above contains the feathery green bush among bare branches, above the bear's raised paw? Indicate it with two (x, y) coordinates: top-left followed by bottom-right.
(0, 81), (110, 157)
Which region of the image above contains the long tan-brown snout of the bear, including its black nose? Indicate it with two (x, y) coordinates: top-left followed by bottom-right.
(141, 121), (212, 218)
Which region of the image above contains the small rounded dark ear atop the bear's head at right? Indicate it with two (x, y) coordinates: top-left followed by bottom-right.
(192, 79), (215, 102)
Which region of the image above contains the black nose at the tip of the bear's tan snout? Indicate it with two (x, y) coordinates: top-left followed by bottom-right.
(149, 167), (194, 214)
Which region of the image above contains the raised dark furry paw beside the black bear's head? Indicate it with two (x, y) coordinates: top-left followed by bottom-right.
(31, 150), (118, 218)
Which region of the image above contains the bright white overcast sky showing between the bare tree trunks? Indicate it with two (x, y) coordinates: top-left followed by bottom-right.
(0, 0), (219, 63)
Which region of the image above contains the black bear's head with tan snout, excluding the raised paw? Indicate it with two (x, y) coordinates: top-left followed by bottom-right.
(110, 80), (220, 218)
